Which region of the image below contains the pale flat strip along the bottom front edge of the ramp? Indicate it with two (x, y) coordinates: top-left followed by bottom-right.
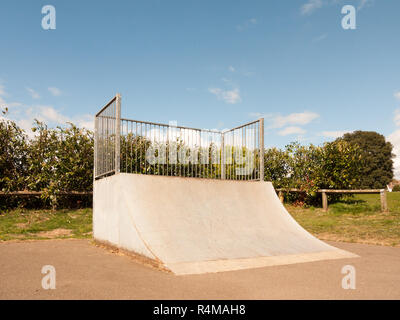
(166, 249), (359, 275)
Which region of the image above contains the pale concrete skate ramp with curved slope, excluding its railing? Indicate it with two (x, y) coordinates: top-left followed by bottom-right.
(93, 173), (356, 275)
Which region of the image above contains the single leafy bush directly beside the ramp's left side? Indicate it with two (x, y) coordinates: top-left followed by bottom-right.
(26, 120), (93, 205)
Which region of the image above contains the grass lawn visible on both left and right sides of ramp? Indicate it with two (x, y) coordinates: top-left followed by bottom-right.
(0, 192), (400, 246)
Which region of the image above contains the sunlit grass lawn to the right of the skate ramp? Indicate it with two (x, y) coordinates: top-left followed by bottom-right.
(285, 192), (400, 246)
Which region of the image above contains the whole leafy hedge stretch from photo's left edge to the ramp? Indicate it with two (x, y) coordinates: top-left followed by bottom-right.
(0, 112), (93, 208)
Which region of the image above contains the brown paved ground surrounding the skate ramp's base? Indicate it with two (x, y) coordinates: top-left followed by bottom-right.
(0, 240), (400, 299)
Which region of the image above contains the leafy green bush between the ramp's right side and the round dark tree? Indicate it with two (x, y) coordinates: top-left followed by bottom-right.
(264, 139), (362, 203)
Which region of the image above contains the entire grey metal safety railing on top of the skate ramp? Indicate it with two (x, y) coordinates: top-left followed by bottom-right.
(94, 95), (264, 181)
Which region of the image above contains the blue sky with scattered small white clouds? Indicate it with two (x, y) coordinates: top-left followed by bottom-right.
(0, 0), (400, 176)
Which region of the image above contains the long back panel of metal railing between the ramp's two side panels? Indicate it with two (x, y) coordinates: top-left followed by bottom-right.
(121, 119), (225, 179)
